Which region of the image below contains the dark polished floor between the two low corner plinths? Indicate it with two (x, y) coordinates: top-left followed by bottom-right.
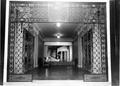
(30, 66), (87, 80)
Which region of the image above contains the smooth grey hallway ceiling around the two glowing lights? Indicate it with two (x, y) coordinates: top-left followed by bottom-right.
(35, 23), (79, 38)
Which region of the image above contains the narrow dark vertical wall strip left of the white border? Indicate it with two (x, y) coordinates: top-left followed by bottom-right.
(0, 0), (6, 85)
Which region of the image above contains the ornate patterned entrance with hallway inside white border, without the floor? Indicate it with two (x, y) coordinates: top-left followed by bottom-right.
(4, 1), (108, 82)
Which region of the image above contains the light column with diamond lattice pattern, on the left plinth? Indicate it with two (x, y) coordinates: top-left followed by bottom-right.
(14, 23), (24, 74)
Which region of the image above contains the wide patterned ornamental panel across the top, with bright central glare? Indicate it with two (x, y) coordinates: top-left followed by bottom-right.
(10, 1), (106, 23)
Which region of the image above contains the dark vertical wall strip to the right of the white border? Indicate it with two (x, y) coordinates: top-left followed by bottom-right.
(110, 0), (120, 86)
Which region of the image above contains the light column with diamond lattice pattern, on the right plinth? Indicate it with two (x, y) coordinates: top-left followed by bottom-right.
(92, 24), (102, 74)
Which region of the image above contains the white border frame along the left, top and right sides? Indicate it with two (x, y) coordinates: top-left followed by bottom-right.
(3, 0), (111, 84)
